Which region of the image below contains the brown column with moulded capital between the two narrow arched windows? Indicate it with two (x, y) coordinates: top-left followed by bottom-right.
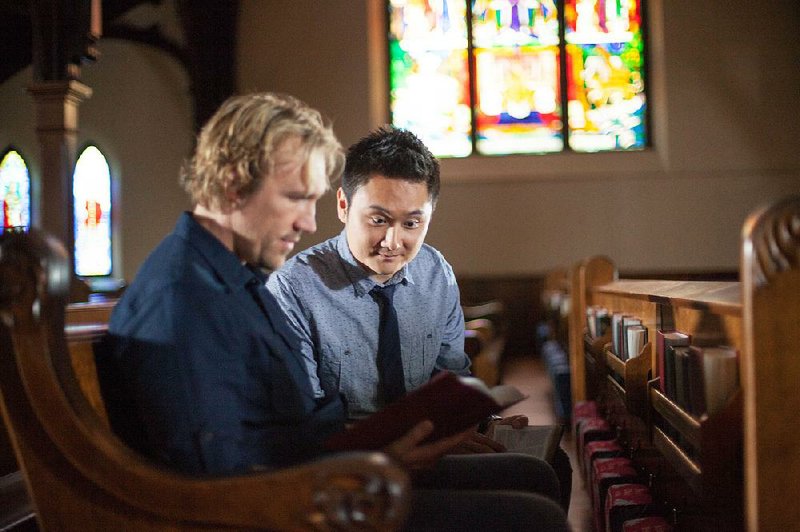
(29, 80), (92, 255)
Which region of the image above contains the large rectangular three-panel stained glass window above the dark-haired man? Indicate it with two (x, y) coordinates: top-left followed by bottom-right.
(388, 0), (647, 157)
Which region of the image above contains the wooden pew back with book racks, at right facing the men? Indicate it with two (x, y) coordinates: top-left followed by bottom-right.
(569, 197), (800, 530)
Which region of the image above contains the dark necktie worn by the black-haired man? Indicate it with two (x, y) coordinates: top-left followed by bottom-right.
(372, 284), (406, 404)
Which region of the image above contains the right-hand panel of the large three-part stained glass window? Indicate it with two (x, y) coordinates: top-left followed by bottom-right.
(564, 0), (647, 152)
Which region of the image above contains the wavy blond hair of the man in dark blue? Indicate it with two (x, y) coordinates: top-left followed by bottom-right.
(180, 92), (344, 210)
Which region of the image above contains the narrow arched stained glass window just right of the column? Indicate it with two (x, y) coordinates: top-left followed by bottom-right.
(72, 146), (112, 276)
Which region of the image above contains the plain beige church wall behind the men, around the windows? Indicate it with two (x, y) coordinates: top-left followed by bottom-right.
(0, 0), (800, 279)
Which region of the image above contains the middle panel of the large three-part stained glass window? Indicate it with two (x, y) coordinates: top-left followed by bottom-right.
(472, 0), (564, 154)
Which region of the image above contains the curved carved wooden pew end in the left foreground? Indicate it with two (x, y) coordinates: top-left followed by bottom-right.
(0, 231), (409, 530)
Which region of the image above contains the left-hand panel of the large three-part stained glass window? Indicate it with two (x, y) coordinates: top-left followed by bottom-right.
(389, 0), (472, 157)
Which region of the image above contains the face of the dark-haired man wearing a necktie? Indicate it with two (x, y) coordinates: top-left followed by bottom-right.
(336, 175), (433, 282)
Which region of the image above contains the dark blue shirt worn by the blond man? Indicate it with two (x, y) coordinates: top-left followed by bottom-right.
(98, 213), (344, 474)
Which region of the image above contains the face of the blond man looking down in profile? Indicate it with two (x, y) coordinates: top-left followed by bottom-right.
(231, 138), (327, 270)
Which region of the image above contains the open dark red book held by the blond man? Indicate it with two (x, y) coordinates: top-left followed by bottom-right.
(325, 371), (526, 451)
